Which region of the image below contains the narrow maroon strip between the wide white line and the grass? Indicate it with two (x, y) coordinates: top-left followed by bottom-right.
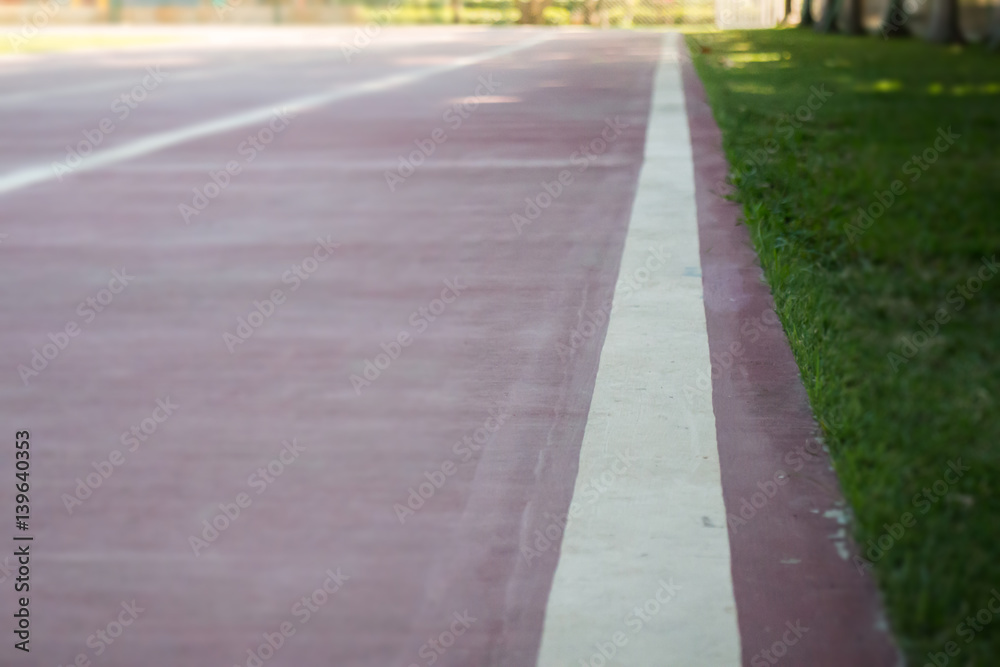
(679, 37), (902, 667)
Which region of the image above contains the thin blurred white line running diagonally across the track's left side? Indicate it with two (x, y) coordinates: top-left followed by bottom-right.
(0, 33), (550, 194)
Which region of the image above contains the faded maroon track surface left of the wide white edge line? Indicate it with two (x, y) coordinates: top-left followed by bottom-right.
(0, 26), (660, 667)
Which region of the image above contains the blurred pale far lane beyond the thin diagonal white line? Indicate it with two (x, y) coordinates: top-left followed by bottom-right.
(0, 31), (548, 172)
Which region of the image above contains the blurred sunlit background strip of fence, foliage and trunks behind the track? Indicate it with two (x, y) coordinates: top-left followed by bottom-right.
(0, 0), (1000, 41)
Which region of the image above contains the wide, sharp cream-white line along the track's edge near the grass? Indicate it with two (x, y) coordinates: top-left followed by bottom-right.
(538, 34), (740, 667)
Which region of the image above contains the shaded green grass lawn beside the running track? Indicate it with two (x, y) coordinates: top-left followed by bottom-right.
(688, 29), (1000, 667)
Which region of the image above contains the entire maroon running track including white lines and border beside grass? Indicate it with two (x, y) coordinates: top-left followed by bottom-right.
(0, 30), (894, 667)
